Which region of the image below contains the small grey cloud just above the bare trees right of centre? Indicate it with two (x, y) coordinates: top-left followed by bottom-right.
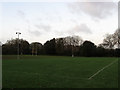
(67, 24), (92, 34)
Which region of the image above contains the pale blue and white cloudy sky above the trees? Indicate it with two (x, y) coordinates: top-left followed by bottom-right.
(0, 1), (118, 45)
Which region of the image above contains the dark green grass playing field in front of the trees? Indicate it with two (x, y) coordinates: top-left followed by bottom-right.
(2, 55), (118, 88)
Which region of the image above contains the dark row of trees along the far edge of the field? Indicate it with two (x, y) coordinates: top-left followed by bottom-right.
(2, 29), (120, 57)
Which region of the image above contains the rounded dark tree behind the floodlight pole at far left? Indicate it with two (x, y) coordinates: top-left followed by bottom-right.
(2, 39), (29, 54)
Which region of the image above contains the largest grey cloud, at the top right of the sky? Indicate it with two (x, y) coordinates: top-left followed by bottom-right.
(68, 2), (117, 19)
